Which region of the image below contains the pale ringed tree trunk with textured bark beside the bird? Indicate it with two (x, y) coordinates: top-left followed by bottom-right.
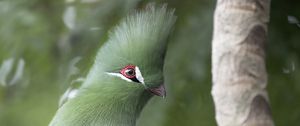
(212, 0), (274, 126)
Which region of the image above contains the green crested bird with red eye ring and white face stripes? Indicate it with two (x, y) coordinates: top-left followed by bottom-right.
(49, 4), (177, 126)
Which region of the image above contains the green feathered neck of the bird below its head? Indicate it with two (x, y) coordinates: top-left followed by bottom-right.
(50, 72), (152, 126)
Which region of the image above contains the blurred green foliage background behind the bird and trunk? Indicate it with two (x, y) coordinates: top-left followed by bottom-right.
(0, 0), (300, 126)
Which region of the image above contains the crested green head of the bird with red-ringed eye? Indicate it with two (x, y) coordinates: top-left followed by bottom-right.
(84, 5), (176, 97)
